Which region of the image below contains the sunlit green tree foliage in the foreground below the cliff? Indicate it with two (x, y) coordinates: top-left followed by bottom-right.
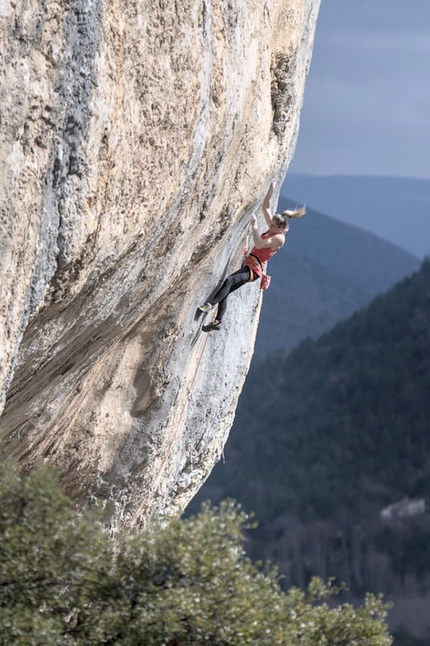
(0, 461), (391, 646)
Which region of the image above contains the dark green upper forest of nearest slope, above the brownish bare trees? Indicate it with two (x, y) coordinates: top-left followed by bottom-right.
(194, 261), (430, 519)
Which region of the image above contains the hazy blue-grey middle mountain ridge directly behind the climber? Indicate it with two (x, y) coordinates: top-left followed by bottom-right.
(255, 196), (419, 355)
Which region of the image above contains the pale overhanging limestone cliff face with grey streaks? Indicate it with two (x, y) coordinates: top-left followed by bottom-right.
(0, 0), (319, 526)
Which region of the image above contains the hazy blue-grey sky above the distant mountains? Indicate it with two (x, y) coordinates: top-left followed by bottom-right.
(290, 0), (430, 178)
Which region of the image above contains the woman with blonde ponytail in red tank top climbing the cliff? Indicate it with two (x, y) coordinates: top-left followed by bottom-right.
(199, 180), (306, 332)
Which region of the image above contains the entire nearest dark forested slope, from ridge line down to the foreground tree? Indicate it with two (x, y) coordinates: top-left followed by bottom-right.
(190, 261), (430, 636)
